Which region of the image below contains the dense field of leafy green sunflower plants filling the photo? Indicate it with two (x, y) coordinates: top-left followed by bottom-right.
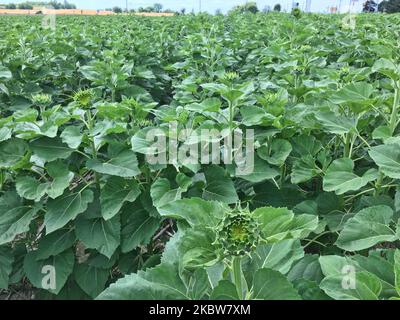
(0, 9), (400, 300)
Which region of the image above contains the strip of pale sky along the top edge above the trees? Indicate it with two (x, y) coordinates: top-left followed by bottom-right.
(0, 0), (364, 13)
